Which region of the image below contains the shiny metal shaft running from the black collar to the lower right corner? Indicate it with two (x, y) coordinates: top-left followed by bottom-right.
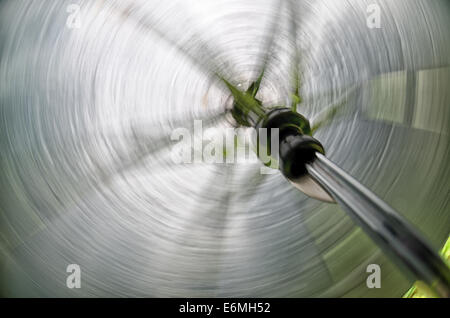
(306, 153), (450, 297)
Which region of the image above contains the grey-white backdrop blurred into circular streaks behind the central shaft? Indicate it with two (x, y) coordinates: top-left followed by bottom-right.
(0, 0), (450, 297)
